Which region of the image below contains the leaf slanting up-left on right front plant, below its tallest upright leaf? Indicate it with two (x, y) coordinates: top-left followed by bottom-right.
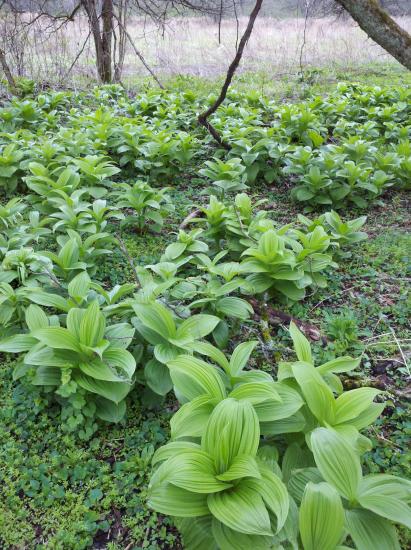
(292, 362), (335, 425)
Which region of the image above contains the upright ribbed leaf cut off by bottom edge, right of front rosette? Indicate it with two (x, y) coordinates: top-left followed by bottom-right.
(299, 482), (345, 550)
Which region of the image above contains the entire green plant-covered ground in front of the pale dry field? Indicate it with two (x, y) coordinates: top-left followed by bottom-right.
(0, 78), (411, 550)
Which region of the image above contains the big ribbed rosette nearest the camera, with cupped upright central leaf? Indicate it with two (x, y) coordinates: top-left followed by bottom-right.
(148, 399), (289, 549)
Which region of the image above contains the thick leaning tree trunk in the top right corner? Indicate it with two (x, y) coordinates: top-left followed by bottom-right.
(336, 0), (411, 70)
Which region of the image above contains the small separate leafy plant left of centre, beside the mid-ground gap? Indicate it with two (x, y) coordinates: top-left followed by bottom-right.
(115, 181), (174, 233)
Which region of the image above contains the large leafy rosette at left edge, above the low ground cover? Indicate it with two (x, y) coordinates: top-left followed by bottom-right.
(0, 300), (136, 422)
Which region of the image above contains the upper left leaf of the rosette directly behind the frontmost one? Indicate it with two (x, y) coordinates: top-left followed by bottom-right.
(167, 355), (226, 400)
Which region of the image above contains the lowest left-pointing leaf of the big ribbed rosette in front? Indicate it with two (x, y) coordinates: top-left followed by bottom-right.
(148, 483), (210, 518)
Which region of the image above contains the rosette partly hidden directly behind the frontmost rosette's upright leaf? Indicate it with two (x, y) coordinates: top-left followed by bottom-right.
(167, 341), (305, 439)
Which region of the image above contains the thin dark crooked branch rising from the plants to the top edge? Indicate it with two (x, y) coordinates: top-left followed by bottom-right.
(197, 0), (263, 151)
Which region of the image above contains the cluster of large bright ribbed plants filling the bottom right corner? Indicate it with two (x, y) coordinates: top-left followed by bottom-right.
(149, 324), (411, 550)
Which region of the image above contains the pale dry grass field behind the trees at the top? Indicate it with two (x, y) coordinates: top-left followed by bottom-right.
(0, 17), (411, 83)
